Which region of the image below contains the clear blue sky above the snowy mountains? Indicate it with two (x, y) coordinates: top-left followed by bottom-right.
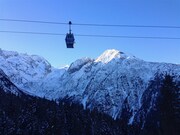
(0, 0), (180, 67)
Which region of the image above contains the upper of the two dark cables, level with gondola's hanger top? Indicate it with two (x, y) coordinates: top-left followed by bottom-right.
(0, 18), (180, 29)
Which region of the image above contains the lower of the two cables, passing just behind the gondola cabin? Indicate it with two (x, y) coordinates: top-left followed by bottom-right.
(0, 31), (180, 40)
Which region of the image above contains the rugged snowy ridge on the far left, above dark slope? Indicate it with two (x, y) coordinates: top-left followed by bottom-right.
(0, 49), (52, 88)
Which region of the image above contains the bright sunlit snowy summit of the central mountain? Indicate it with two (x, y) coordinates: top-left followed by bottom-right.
(95, 49), (135, 63)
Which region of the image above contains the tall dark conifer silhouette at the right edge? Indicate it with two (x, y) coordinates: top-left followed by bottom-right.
(160, 75), (180, 135)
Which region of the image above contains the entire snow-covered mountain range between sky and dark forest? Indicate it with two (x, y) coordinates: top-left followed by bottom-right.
(0, 49), (180, 123)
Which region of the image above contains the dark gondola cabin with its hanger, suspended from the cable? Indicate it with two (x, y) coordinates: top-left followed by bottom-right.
(65, 21), (75, 48)
